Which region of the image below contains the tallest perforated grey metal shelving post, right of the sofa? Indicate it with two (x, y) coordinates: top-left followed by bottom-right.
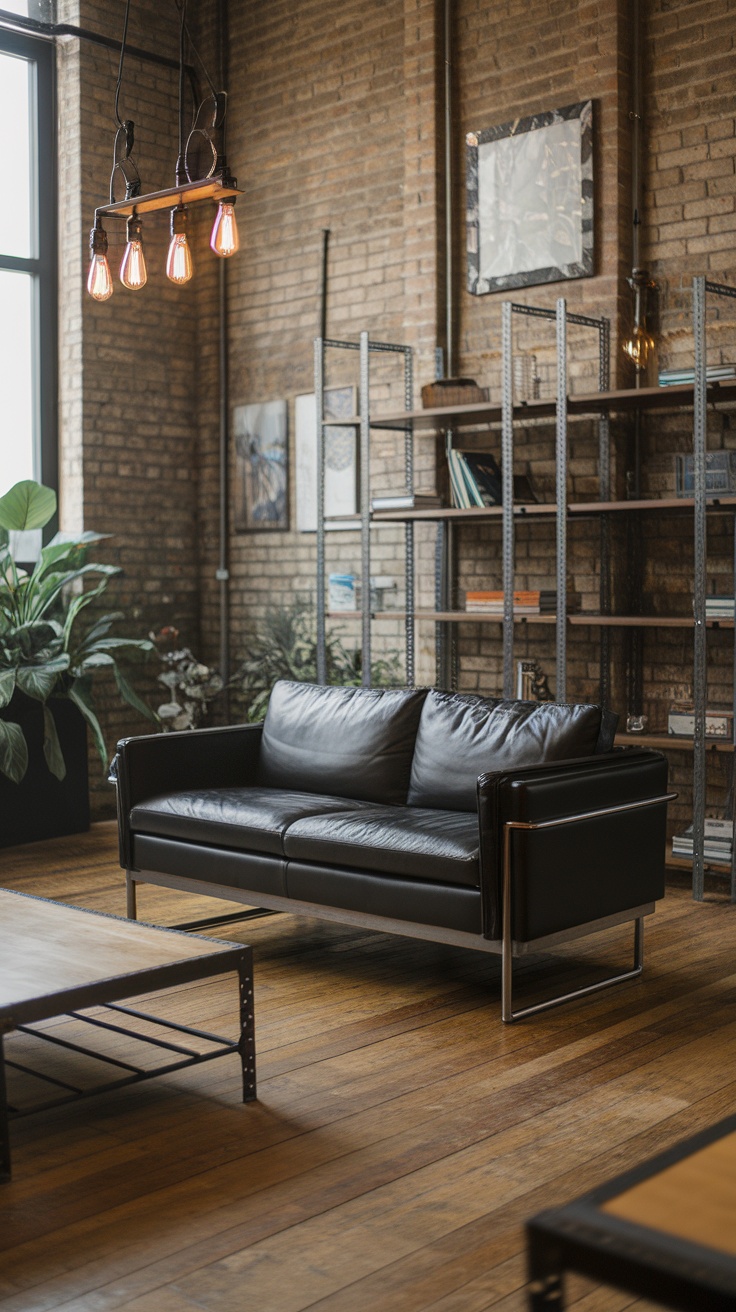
(693, 277), (707, 901)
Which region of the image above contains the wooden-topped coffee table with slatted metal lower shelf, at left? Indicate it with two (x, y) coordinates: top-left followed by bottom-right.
(0, 890), (256, 1179)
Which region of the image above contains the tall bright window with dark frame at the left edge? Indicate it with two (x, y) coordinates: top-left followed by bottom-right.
(0, 30), (58, 496)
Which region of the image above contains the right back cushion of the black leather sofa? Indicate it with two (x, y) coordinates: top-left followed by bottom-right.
(408, 691), (618, 811)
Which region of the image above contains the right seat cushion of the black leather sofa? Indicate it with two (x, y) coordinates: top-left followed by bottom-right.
(283, 807), (480, 888)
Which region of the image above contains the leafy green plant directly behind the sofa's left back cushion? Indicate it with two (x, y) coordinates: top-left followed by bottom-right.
(231, 601), (403, 722)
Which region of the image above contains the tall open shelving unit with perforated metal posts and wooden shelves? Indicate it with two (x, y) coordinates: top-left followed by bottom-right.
(316, 278), (736, 900)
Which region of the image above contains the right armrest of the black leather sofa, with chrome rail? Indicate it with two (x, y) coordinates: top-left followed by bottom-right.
(478, 748), (666, 942)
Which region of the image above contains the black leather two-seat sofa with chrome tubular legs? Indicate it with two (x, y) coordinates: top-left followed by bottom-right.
(114, 682), (668, 1021)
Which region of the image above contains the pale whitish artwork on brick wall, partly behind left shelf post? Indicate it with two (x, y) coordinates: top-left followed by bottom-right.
(294, 387), (358, 533)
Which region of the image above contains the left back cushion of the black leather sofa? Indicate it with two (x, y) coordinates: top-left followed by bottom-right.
(257, 681), (426, 806)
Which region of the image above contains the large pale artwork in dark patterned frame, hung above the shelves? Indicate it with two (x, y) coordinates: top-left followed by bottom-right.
(466, 100), (593, 297)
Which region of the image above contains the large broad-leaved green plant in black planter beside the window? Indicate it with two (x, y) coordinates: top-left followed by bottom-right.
(0, 479), (156, 846)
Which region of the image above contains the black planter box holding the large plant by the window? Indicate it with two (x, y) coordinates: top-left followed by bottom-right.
(0, 691), (89, 848)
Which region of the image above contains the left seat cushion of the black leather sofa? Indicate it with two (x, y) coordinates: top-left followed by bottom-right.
(130, 787), (372, 857)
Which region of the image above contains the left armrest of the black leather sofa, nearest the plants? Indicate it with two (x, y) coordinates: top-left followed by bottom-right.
(110, 724), (264, 869)
